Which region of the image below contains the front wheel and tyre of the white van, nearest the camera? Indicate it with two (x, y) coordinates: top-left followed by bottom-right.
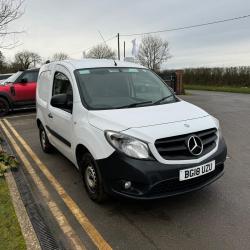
(80, 153), (107, 203)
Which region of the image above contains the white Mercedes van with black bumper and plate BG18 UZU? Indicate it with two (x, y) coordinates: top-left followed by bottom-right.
(37, 59), (227, 202)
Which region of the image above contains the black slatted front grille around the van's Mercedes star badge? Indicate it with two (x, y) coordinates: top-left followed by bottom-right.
(155, 128), (217, 160)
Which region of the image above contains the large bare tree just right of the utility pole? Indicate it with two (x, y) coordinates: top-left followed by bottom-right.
(138, 35), (171, 71)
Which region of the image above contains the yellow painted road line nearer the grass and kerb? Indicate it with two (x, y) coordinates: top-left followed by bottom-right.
(0, 121), (86, 250)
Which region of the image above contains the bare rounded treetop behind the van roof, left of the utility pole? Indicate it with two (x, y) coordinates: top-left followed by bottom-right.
(86, 44), (116, 59)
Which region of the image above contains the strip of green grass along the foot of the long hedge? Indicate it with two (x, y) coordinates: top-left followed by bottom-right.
(184, 84), (250, 94)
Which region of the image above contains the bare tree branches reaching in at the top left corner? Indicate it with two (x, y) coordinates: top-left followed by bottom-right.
(0, 0), (24, 48)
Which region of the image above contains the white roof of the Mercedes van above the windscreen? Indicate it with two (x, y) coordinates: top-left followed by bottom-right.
(43, 59), (145, 69)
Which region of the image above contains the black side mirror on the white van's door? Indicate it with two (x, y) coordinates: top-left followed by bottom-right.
(50, 94), (73, 113)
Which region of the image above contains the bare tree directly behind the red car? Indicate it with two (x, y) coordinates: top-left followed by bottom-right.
(15, 50), (42, 69)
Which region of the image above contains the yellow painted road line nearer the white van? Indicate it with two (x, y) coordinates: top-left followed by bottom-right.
(4, 119), (112, 250)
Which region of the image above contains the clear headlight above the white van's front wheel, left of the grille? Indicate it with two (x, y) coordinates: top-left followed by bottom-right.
(105, 131), (150, 159)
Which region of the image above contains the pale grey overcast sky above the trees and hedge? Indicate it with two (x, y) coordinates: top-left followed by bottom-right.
(3, 0), (250, 68)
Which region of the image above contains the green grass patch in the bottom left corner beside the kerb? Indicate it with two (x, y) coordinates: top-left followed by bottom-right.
(0, 177), (26, 250)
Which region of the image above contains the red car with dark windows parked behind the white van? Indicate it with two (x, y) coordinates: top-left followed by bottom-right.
(0, 69), (39, 116)
